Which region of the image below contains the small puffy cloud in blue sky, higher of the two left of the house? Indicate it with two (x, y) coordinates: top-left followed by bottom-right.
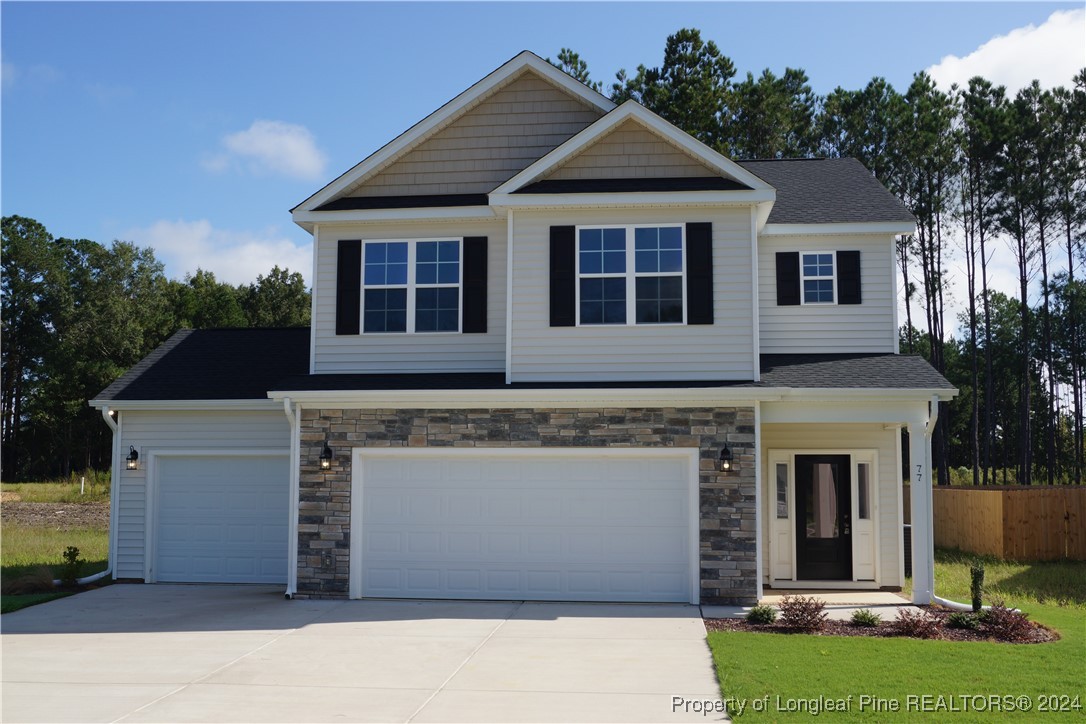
(201, 120), (327, 180)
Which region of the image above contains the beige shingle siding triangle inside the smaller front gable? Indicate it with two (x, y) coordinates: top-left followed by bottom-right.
(545, 120), (719, 180)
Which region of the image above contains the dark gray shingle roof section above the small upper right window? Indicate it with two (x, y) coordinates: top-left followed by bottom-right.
(736, 158), (915, 224)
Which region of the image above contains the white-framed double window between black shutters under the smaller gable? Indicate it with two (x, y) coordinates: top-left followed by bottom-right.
(577, 226), (686, 326)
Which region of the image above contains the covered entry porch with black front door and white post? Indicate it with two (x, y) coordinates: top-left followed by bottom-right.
(759, 390), (955, 604)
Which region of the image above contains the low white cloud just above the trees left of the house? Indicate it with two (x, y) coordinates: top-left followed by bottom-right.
(122, 219), (313, 284)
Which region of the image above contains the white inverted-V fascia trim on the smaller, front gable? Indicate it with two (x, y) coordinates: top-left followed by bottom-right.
(493, 101), (773, 199)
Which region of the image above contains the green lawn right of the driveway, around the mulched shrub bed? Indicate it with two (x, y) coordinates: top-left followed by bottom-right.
(709, 551), (1086, 723)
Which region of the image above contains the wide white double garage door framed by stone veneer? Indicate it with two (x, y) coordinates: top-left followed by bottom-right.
(352, 448), (696, 601)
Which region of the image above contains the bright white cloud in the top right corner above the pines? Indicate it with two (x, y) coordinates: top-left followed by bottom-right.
(927, 9), (1086, 96)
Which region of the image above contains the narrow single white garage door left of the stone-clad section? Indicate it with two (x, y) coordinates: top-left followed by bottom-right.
(152, 455), (290, 583)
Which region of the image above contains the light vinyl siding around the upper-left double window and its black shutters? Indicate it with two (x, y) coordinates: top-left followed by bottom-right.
(313, 219), (506, 373)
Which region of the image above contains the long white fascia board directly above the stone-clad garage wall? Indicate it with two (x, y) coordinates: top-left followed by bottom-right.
(268, 388), (781, 409)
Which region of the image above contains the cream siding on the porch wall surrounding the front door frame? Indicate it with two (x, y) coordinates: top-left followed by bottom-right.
(759, 422), (902, 586)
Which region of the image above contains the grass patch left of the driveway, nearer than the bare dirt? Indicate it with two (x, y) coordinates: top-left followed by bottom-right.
(0, 524), (110, 613)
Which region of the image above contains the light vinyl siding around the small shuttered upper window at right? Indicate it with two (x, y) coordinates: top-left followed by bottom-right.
(758, 234), (897, 354)
